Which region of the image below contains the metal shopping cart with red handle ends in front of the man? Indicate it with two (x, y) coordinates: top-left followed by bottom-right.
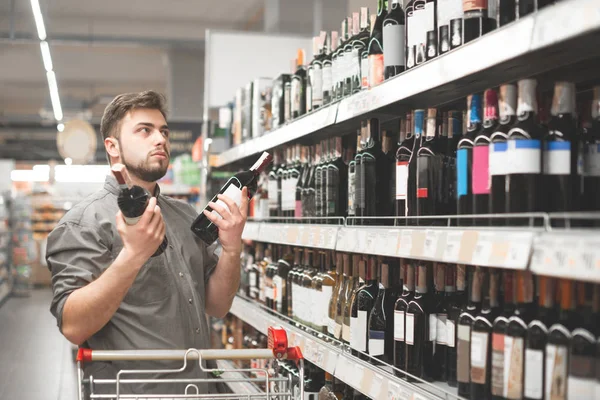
(77, 327), (304, 400)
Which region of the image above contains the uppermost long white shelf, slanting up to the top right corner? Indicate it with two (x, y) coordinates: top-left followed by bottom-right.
(215, 0), (600, 167)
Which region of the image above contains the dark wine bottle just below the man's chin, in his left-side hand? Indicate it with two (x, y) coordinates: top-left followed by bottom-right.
(112, 164), (169, 257)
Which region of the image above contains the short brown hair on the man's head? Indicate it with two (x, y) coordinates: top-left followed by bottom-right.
(100, 90), (167, 139)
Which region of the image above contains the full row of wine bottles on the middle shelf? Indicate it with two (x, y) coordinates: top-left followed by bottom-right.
(247, 79), (600, 223)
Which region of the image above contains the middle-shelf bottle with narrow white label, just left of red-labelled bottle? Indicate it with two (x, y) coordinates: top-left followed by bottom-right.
(396, 113), (415, 220)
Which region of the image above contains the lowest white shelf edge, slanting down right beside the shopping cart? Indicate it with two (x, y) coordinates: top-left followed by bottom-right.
(230, 297), (459, 400)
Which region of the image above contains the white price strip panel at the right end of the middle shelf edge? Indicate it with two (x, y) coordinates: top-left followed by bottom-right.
(530, 231), (600, 283)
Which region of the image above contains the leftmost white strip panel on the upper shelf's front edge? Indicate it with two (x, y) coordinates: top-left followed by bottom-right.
(215, 103), (338, 167)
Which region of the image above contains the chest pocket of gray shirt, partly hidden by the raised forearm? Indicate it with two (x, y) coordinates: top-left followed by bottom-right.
(123, 254), (172, 306)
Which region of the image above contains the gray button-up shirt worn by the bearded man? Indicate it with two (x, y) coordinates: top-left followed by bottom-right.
(46, 175), (217, 394)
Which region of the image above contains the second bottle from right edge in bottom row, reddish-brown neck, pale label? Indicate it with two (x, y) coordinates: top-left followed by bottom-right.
(544, 279), (583, 400)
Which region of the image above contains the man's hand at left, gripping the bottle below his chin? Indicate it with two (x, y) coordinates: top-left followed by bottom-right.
(117, 197), (166, 267)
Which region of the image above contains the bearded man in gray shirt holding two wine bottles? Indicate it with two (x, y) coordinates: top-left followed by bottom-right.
(46, 91), (247, 394)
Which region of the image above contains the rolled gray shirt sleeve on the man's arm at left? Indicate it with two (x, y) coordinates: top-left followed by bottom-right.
(46, 222), (113, 332)
